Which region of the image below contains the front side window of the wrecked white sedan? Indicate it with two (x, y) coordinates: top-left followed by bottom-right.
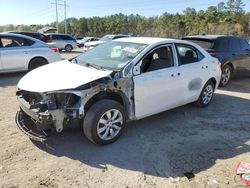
(141, 46), (174, 73)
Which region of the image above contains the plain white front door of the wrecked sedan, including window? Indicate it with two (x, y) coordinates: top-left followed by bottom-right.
(133, 44), (182, 119)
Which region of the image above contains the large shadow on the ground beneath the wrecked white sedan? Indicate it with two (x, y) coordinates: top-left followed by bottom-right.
(31, 94), (250, 177)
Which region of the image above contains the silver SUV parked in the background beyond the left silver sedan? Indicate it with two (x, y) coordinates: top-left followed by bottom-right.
(45, 33), (77, 52)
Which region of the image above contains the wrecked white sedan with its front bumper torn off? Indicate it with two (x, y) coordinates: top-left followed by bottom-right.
(16, 37), (221, 145)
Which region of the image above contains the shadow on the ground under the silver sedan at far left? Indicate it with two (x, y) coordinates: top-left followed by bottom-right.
(0, 72), (27, 87)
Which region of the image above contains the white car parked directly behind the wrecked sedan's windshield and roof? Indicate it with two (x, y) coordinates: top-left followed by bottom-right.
(83, 34), (130, 51)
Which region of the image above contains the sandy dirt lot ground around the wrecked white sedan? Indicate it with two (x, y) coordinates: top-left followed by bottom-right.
(0, 50), (250, 188)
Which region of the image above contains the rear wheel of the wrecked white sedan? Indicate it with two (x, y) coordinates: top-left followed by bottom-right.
(194, 80), (215, 108)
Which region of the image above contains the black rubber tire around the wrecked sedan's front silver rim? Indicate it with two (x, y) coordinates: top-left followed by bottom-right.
(83, 99), (126, 145)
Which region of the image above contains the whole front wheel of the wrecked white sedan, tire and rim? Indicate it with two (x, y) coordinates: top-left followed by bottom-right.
(83, 99), (126, 145)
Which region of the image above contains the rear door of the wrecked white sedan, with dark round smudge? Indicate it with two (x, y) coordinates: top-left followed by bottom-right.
(176, 43), (211, 103)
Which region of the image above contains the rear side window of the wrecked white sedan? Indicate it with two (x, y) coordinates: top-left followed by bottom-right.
(176, 44), (205, 65)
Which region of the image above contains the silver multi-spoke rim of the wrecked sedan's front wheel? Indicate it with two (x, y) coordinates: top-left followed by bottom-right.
(97, 109), (123, 140)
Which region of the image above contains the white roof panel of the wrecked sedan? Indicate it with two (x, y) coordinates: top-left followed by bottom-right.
(115, 37), (186, 44)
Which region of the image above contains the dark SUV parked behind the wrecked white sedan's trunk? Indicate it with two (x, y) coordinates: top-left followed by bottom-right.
(183, 35), (250, 87)
